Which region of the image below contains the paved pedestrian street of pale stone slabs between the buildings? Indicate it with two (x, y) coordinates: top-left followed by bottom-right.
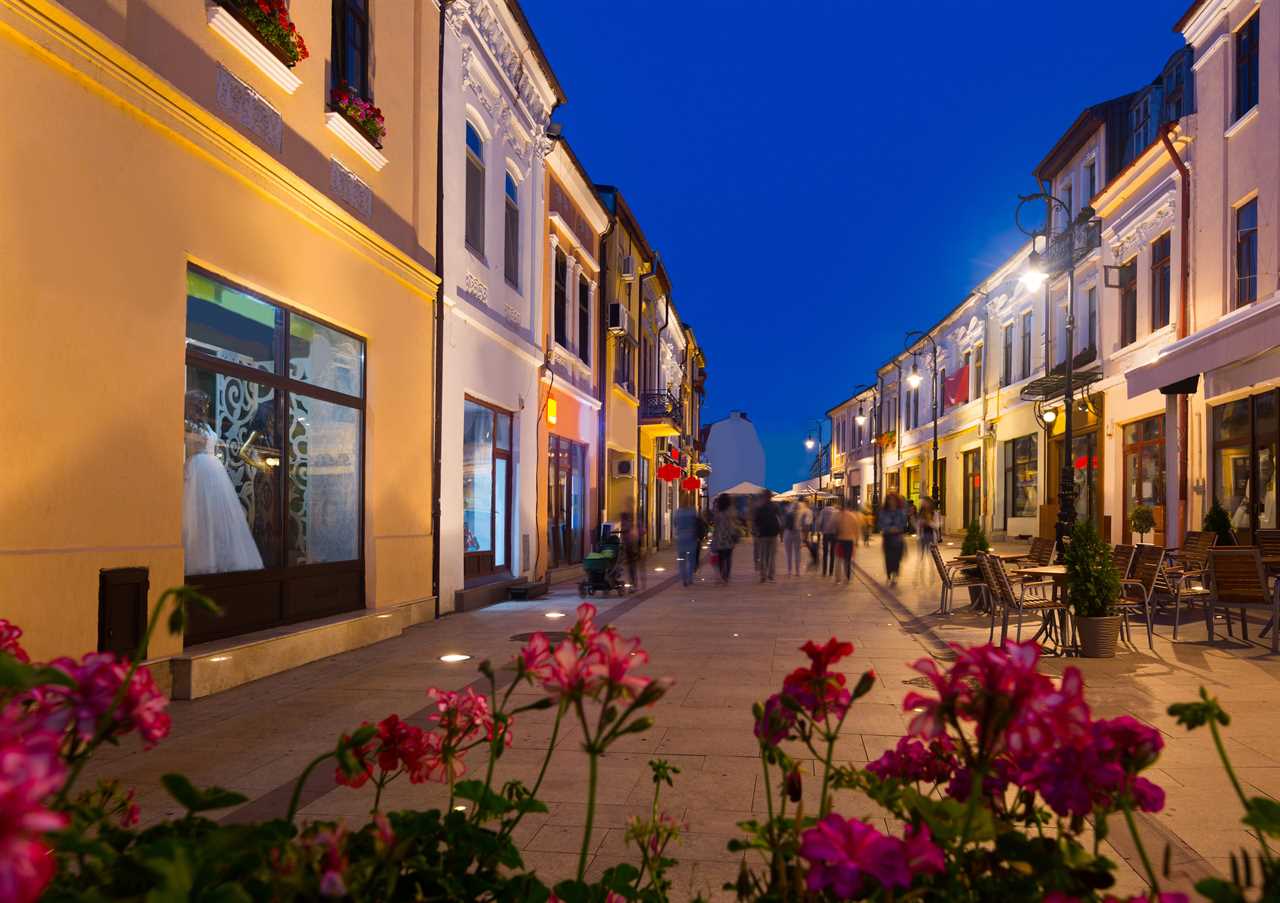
(85, 535), (1280, 899)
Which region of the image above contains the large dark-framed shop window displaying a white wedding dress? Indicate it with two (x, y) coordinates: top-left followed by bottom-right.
(182, 268), (365, 642)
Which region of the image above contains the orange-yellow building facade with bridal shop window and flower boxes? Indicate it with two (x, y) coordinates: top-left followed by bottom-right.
(0, 0), (439, 676)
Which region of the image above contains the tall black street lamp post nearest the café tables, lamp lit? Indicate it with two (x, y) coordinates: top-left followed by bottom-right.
(1015, 191), (1094, 564)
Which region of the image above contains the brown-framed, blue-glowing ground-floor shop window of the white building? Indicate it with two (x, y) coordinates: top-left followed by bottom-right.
(462, 398), (512, 579)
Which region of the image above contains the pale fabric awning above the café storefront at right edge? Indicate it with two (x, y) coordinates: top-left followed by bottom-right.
(1125, 293), (1280, 398)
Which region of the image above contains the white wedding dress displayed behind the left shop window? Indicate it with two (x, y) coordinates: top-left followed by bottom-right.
(182, 424), (262, 574)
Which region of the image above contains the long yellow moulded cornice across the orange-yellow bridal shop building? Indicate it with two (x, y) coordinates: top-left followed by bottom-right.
(0, 0), (440, 301)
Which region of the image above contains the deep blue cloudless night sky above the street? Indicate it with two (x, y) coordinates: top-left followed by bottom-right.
(524, 0), (1189, 489)
